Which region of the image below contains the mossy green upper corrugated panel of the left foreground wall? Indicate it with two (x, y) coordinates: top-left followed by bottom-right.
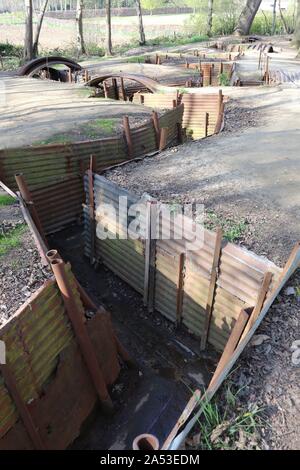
(0, 265), (84, 437)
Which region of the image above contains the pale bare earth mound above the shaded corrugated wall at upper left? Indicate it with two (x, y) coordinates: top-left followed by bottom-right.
(0, 77), (155, 148)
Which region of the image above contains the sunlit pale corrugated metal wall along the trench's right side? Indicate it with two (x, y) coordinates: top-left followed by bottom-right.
(84, 175), (282, 350)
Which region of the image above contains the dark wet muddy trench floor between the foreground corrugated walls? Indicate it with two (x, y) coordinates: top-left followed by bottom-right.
(49, 226), (219, 450)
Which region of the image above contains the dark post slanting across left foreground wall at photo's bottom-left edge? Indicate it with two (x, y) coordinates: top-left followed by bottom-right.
(0, 364), (46, 450)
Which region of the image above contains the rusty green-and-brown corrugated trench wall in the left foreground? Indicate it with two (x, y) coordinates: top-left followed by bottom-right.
(0, 265), (120, 450)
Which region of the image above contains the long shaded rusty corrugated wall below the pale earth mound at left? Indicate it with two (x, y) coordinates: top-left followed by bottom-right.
(0, 106), (183, 234)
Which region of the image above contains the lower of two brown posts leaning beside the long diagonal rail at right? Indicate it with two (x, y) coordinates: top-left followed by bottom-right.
(209, 309), (249, 387)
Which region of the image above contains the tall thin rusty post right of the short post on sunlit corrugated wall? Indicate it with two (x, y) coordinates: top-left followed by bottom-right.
(200, 228), (223, 351)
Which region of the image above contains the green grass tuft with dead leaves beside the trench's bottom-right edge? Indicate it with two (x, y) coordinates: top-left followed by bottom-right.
(192, 383), (266, 450)
